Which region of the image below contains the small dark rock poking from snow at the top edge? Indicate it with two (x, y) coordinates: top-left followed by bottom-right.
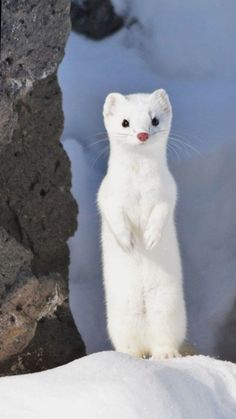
(71, 0), (124, 40)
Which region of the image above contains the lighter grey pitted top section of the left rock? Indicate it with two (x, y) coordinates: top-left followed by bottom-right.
(1, 0), (70, 94)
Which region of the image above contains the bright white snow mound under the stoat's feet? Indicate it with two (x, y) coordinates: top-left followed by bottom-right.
(0, 352), (236, 419)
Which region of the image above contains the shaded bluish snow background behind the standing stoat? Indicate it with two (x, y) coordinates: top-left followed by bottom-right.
(59, 0), (236, 355)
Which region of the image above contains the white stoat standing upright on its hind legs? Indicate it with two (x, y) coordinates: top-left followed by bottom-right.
(98, 89), (186, 359)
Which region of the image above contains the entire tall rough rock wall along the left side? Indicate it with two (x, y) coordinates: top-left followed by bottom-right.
(0, 0), (85, 375)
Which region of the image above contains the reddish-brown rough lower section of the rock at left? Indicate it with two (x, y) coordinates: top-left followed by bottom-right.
(0, 240), (67, 362)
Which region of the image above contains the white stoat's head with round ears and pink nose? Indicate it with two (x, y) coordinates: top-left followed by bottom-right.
(103, 89), (172, 151)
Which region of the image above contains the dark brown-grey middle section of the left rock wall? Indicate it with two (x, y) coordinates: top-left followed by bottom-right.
(0, 75), (77, 275)
